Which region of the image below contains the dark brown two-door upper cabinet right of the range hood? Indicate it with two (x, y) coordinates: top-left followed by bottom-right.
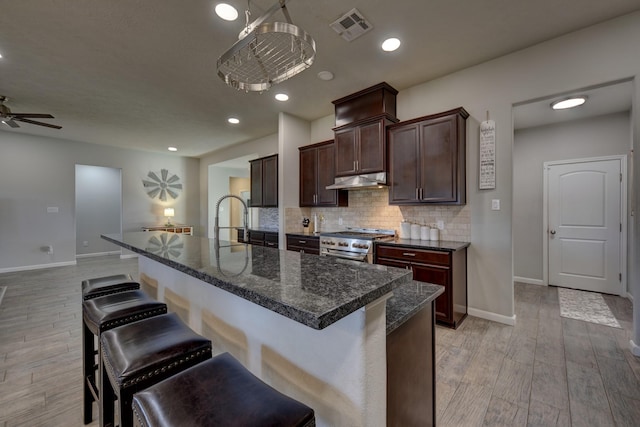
(387, 107), (469, 205)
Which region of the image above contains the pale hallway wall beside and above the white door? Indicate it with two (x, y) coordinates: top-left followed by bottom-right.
(513, 112), (631, 281)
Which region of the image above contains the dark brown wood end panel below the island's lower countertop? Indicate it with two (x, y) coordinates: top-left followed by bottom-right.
(387, 302), (436, 427)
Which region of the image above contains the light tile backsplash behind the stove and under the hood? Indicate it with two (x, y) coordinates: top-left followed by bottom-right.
(285, 187), (471, 242)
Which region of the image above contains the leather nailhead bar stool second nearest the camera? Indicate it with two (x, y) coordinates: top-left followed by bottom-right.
(99, 313), (211, 427)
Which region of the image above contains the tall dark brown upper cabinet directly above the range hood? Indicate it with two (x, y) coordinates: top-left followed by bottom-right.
(333, 83), (398, 176)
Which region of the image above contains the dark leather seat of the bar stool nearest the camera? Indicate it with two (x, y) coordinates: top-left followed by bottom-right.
(133, 353), (315, 427)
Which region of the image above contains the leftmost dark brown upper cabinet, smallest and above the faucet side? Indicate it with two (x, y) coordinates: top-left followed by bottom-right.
(249, 154), (278, 208)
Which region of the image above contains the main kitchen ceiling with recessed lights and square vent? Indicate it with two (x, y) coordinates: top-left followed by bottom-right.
(0, 0), (640, 156)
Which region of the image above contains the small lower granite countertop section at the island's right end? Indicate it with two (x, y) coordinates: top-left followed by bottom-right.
(387, 280), (444, 335)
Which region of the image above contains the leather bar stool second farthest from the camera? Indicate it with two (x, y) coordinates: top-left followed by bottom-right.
(82, 290), (167, 424)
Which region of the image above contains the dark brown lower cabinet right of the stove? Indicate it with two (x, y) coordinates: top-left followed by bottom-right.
(376, 244), (467, 329)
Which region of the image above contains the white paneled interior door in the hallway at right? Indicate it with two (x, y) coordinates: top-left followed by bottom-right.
(545, 159), (623, 295)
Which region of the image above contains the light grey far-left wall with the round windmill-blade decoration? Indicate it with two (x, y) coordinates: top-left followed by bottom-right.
(0, 131), (200, 272)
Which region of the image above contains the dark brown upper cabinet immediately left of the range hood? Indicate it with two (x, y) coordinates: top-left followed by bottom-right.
(299, 141), (348, 207)
